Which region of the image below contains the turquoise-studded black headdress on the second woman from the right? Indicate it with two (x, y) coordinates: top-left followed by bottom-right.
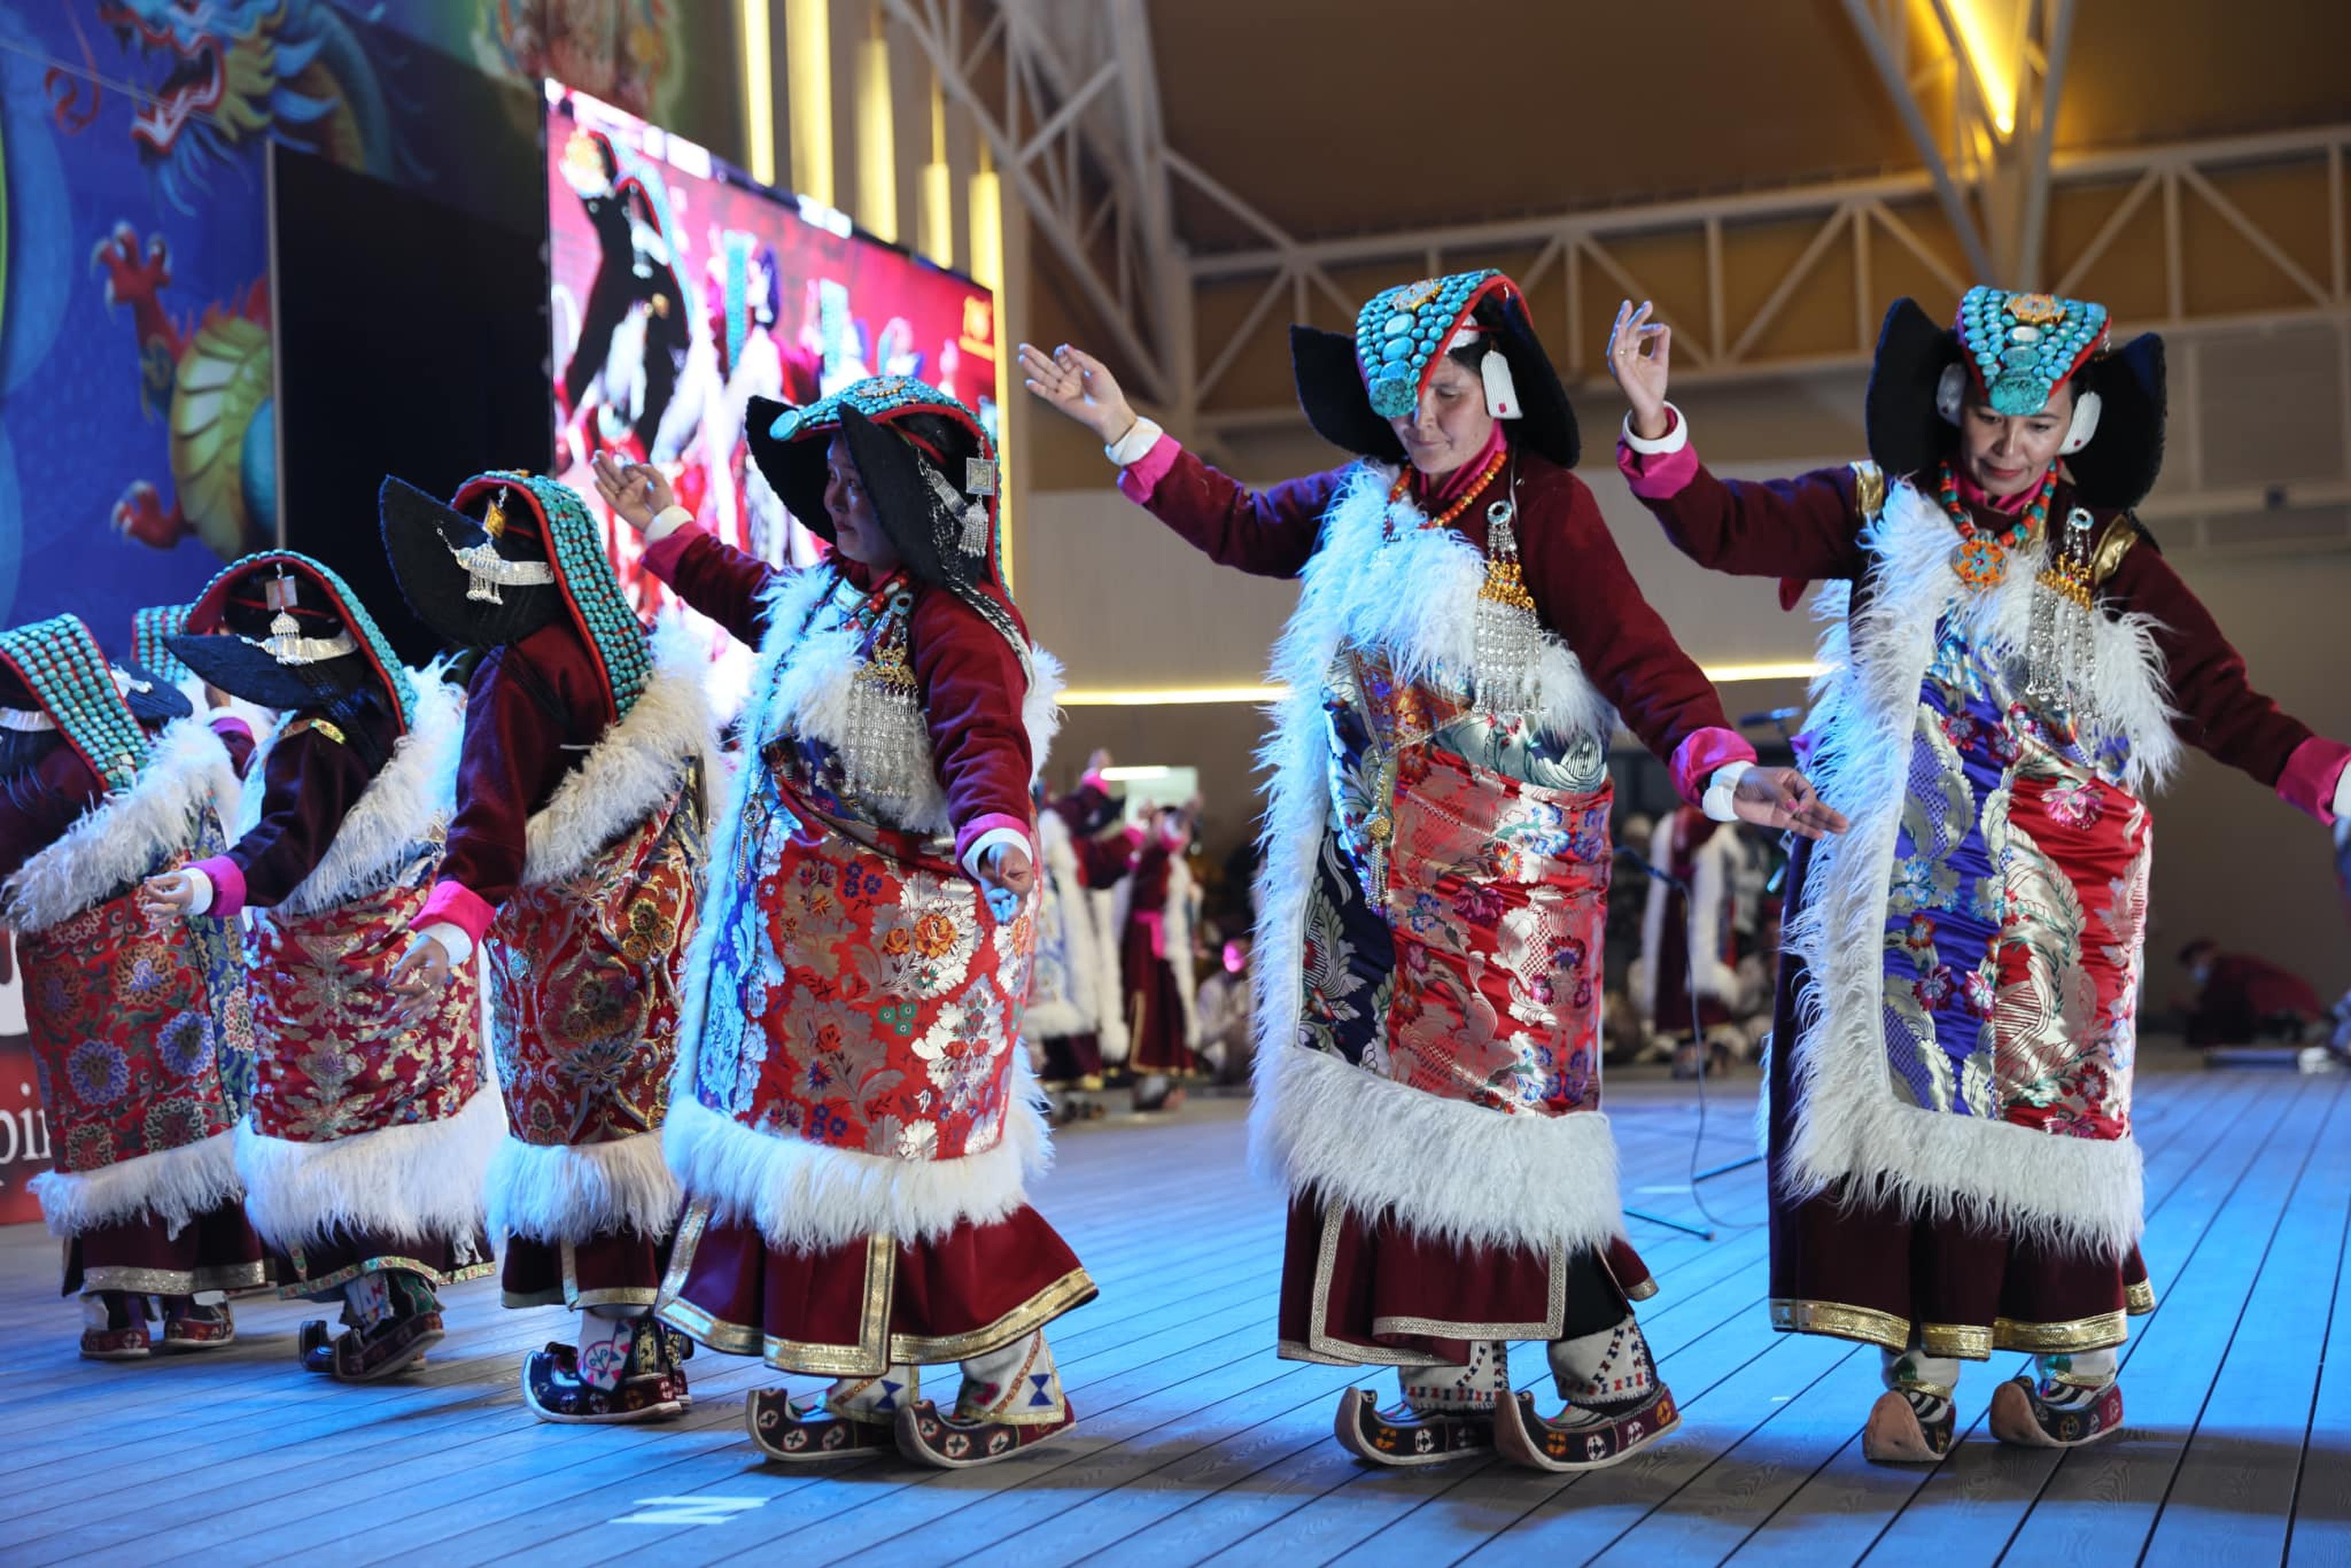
(1291, 268), (1580, 468)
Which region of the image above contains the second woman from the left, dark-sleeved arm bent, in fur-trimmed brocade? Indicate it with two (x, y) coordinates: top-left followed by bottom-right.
(146, 561), (501, 1382)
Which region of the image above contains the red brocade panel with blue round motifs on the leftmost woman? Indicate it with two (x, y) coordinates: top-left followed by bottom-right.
(17, 886), (235, 1173)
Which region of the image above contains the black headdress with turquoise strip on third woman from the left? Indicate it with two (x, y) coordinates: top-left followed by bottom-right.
(376, 468), (654, 721)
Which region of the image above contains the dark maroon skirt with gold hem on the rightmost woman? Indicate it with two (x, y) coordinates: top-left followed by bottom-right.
(1768, 841), (2156, 1361)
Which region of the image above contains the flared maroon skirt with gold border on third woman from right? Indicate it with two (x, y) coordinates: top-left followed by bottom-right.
(658, 1201), (1096, 1377)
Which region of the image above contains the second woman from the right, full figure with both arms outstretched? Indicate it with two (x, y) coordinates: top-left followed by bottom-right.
(1021, 273), (1834, 1469)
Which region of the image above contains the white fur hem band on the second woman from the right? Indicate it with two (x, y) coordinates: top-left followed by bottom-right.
(1248, 1046), (1624, 1251)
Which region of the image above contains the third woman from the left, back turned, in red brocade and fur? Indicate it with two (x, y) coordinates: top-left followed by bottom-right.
(381, 472), (712, 1422)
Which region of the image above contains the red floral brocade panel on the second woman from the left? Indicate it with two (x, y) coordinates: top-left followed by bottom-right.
(245, 860), (482, 1143)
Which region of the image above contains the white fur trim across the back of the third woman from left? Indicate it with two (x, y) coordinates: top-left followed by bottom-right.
(522, 611), (715, 886)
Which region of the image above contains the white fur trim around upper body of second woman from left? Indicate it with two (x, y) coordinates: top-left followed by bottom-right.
(238, 665), (465, 914)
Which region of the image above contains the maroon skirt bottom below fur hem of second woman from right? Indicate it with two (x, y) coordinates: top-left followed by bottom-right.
(1279, 1197), (1658, 1366)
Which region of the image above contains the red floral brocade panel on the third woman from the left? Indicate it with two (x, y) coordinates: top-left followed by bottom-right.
(489, 783), (703, 1145)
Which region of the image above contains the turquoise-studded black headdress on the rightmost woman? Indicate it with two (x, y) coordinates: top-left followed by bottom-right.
(1867, 287), (2165, 510)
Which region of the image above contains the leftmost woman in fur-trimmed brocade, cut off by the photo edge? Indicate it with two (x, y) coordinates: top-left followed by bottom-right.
(0, 616), (268, 1361)
